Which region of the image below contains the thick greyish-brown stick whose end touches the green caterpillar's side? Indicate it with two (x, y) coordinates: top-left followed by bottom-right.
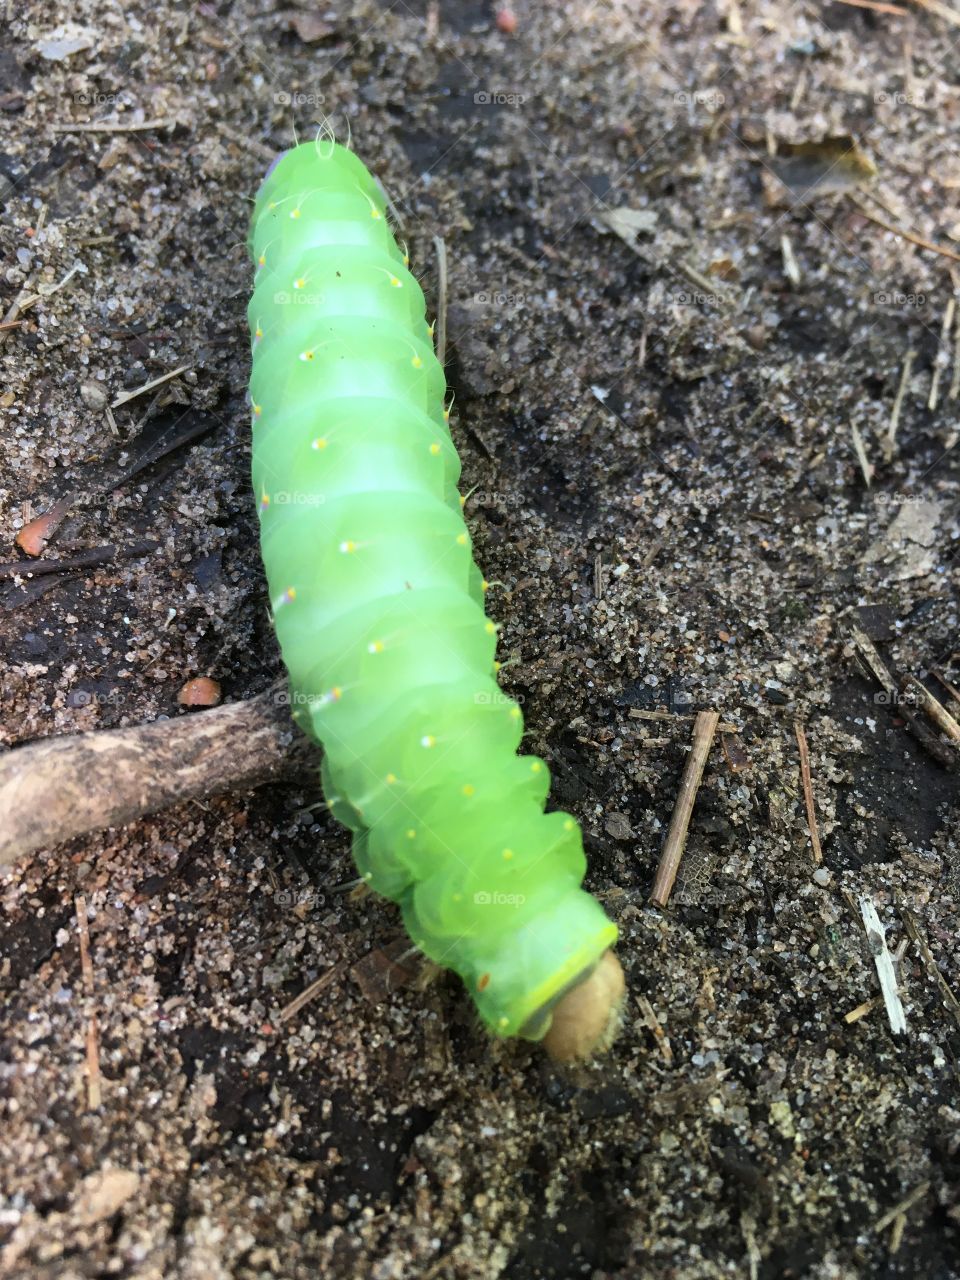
(0, 685), (317, 867)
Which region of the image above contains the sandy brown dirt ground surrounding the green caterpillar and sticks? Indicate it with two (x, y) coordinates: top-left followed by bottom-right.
(0, 0), (960, 1280)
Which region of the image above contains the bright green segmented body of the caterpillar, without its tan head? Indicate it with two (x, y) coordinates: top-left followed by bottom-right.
(248, 140), (622, 1039)
